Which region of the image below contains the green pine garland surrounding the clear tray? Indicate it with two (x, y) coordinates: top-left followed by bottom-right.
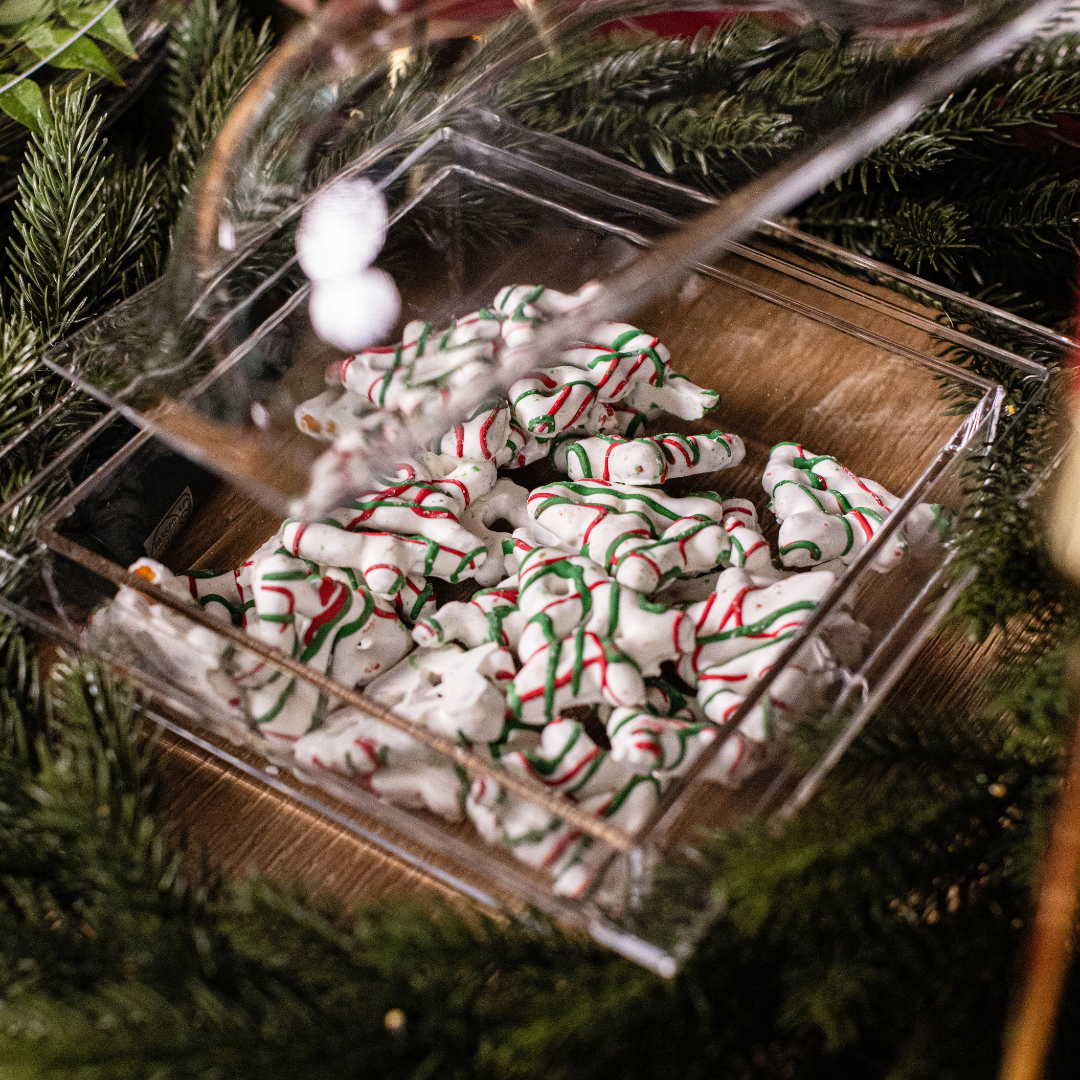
(0, 0), (1080, 1080)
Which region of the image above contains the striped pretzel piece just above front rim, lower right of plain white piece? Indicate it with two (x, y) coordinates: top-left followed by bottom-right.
(499, 716), (632, 799)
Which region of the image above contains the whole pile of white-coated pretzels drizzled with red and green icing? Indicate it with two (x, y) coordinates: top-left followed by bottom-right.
(92, 286), (933, 896)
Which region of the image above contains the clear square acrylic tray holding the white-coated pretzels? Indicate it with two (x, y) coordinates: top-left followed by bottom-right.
(0, 110), (1067, 974)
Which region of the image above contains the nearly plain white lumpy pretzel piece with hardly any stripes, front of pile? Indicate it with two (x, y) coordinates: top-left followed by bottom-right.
(365, 642), (515, 742)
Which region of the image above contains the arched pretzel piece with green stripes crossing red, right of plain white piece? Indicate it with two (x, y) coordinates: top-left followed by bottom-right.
(507, 630), (645, 727)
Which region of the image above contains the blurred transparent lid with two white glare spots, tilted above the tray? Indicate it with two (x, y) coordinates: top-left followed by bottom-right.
(44, 0), (1059, 518)
